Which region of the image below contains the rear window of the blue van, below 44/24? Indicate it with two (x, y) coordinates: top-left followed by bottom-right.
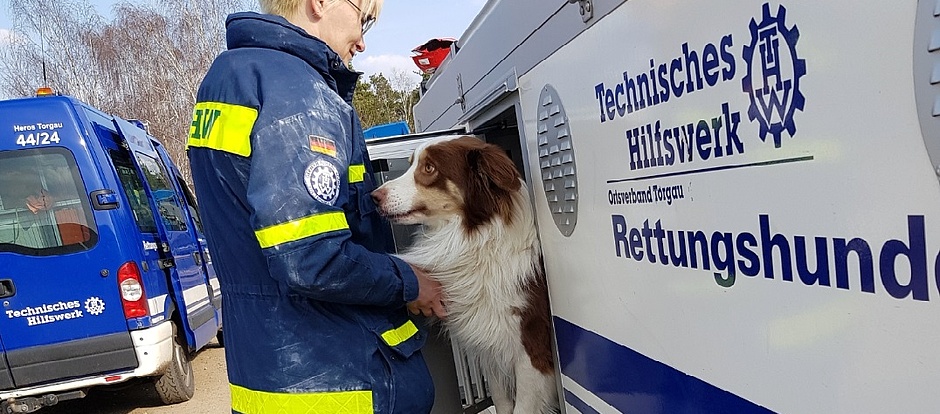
(0, 147), (98, 256)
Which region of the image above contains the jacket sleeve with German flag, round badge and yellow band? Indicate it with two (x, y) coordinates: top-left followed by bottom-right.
(248, 89), (418, 306)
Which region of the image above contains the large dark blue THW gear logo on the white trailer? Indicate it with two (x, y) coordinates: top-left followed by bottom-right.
(741, 3), (806, 148)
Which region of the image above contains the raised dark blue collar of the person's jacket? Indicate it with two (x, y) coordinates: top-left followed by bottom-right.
(225, 12), (362, 104)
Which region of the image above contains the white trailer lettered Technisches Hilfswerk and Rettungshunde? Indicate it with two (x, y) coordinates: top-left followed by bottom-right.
(388, 0), (940, 413)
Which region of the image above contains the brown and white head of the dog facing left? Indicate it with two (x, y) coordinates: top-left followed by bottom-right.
(372, 136), (522, 230)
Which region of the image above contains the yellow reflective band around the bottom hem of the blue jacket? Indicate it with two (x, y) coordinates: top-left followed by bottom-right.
(229, 384), (373, 414)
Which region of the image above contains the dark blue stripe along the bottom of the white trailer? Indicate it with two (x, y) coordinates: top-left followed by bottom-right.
(554, 316), (773, 414)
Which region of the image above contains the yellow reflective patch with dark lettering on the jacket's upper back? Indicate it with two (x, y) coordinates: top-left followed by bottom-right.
(186, 102), (258, 157)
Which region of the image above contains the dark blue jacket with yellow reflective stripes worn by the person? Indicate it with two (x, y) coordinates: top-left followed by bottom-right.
(188, 13), (433, 414)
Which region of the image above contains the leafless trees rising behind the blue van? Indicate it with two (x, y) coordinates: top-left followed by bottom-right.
(0, 0), (248, 183)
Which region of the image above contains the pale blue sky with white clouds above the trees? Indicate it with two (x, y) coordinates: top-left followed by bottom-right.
(0, 0), (486, 85)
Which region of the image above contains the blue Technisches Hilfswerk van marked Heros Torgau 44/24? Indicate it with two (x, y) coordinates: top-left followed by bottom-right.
(0, 95), (222, 413)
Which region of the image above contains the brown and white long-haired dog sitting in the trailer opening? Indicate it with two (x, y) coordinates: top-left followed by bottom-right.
(372, 136), (558, 414)
